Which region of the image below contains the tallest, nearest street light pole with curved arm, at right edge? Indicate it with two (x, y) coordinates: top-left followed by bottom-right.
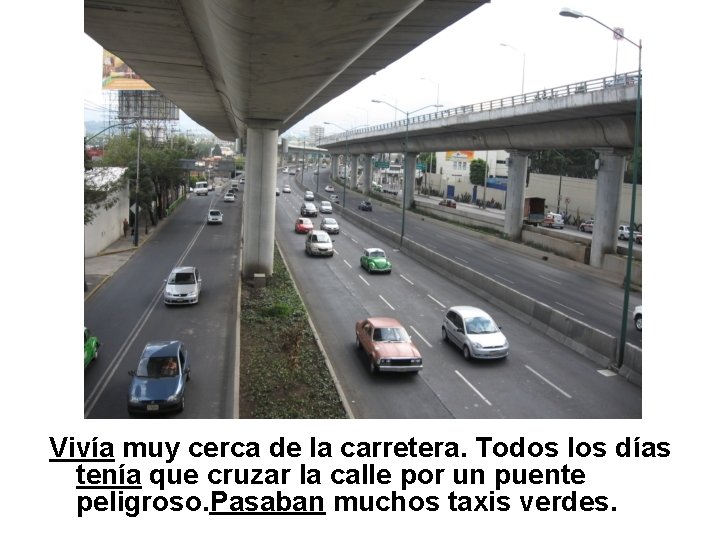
(560, 8), (642, 369)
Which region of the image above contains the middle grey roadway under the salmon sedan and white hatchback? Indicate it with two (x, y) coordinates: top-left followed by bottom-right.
(276, 174), (642, 418)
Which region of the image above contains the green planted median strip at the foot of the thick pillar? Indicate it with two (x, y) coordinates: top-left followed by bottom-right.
(239, 247), (346, 418)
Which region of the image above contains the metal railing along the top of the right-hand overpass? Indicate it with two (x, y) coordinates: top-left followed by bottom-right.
(320, 71), (640, 145)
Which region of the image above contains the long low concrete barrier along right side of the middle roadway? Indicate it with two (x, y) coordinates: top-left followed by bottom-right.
(336, 200), (642, 386)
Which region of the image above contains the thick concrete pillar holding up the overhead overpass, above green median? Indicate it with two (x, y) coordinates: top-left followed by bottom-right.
(241, 124), (278, 279)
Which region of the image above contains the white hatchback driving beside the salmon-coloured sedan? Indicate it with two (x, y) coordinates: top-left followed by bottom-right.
(441, 306), (510, 360)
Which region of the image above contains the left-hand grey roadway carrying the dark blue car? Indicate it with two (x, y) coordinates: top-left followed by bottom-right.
(84, 184), (242, 418)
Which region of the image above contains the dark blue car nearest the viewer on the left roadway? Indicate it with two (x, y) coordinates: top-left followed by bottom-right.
(127, 340), (190, 414)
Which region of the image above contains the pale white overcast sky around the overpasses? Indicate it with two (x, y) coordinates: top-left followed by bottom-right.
(83, 0), (648, 139)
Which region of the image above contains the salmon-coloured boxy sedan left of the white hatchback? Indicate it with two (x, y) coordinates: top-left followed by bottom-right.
(355, 317), (422, 373)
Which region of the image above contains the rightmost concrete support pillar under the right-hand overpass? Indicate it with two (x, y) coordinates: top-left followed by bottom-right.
(590, 148), (625, 268)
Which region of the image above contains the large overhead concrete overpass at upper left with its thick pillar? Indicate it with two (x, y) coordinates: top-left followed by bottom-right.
(84, 0), (489, 277)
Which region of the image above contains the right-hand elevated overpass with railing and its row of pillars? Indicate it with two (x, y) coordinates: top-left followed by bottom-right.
(320, 73), (639, 267)
